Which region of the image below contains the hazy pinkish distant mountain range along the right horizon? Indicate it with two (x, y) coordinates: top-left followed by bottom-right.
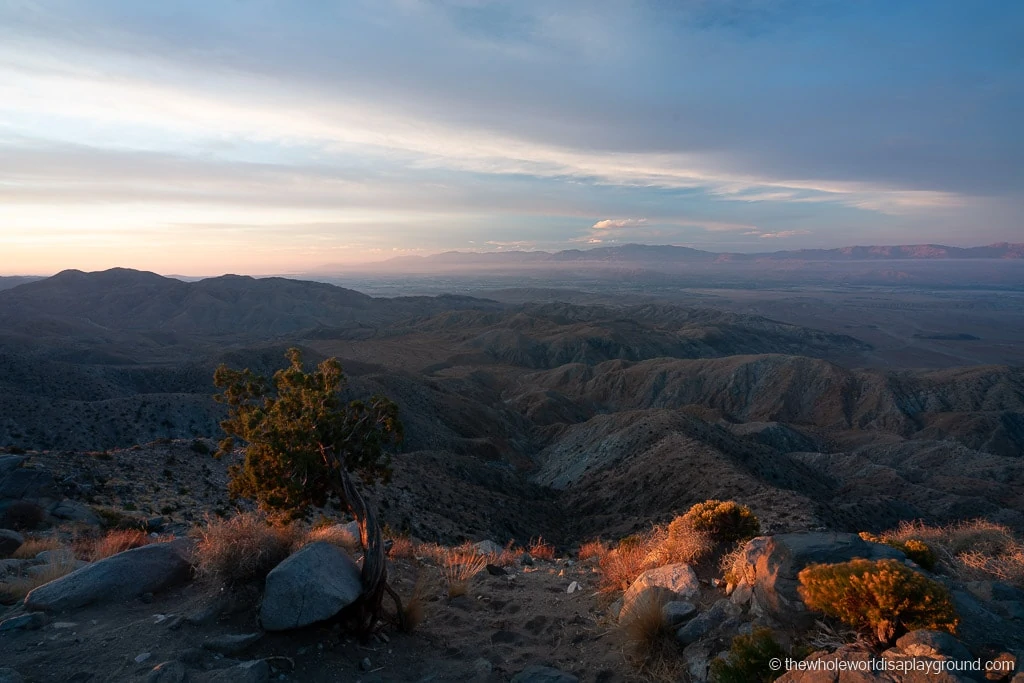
(368, 242), (1024, 267)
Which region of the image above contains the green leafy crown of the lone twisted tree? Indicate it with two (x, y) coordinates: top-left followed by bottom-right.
(213, 348), (401, 516)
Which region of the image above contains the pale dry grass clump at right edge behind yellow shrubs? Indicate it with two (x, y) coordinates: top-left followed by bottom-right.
(881, 519), (1024, 588)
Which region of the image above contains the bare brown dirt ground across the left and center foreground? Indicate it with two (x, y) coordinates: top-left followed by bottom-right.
(0, 548), (679, 683)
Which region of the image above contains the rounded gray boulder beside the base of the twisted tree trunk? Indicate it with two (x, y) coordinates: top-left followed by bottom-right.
(260, 542), (362, 631)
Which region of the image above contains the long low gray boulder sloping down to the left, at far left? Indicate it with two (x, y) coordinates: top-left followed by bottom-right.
(25, 539), (191, 611)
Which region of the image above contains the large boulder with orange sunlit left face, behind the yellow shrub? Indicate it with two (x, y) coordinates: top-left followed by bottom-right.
(733, 531), (905, 627)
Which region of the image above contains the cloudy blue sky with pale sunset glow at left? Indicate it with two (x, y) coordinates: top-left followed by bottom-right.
(0, 0), (1024, 275)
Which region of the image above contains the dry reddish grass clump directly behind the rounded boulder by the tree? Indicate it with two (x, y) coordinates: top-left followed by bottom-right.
(196, 512), (303, 585)
